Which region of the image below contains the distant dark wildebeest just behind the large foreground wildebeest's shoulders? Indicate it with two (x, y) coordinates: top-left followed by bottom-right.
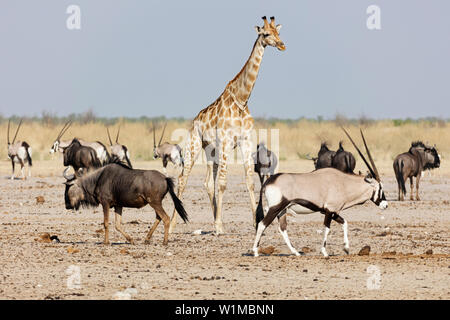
(63, 138), (102, 173)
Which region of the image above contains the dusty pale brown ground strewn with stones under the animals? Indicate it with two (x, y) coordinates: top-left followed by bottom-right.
(0, 160), (450, 299)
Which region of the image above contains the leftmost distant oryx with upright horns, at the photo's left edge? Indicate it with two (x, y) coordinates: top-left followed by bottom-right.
(7, 120), (33, 180)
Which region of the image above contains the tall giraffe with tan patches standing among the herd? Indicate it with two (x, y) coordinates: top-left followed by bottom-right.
(169, 16), (286, 234)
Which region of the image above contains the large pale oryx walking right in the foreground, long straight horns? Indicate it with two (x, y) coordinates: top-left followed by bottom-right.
(253, 129), (388, 257)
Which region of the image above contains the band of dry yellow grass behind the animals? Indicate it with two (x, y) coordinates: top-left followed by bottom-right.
(0, 120), (450, 175)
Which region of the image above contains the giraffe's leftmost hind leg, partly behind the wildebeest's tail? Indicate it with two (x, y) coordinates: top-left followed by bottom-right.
(169, 128), (202, 233)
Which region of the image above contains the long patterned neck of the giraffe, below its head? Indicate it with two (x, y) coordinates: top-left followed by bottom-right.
(227, 36), (264, 105)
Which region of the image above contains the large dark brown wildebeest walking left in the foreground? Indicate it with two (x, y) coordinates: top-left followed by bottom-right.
(63, 162), (188, 245)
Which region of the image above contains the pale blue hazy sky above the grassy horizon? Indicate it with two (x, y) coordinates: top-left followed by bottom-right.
(0, 0), (450, 118)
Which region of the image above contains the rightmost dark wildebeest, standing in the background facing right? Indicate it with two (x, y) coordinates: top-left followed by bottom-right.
(394, 141), (441, 201)
